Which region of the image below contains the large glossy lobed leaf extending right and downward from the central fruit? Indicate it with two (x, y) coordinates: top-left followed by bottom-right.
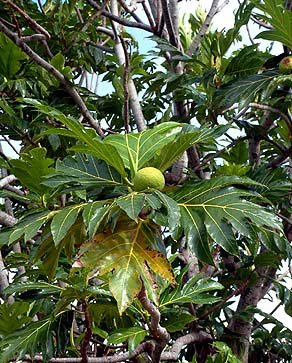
(172, 176), (281, 263)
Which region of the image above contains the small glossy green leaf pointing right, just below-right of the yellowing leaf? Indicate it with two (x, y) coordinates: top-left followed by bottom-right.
(159, 274), (223, 307)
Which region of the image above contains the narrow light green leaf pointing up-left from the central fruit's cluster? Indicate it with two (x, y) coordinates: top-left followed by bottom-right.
(25, 99), (127, 178)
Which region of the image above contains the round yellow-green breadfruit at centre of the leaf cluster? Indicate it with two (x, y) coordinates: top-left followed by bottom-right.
(133, 166), (165, 192)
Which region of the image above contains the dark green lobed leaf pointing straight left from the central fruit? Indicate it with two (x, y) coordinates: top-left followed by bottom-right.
(42, 154), (123, 188)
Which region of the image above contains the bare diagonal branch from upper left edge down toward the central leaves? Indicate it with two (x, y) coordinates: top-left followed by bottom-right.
(0, 21), (104, 137)
